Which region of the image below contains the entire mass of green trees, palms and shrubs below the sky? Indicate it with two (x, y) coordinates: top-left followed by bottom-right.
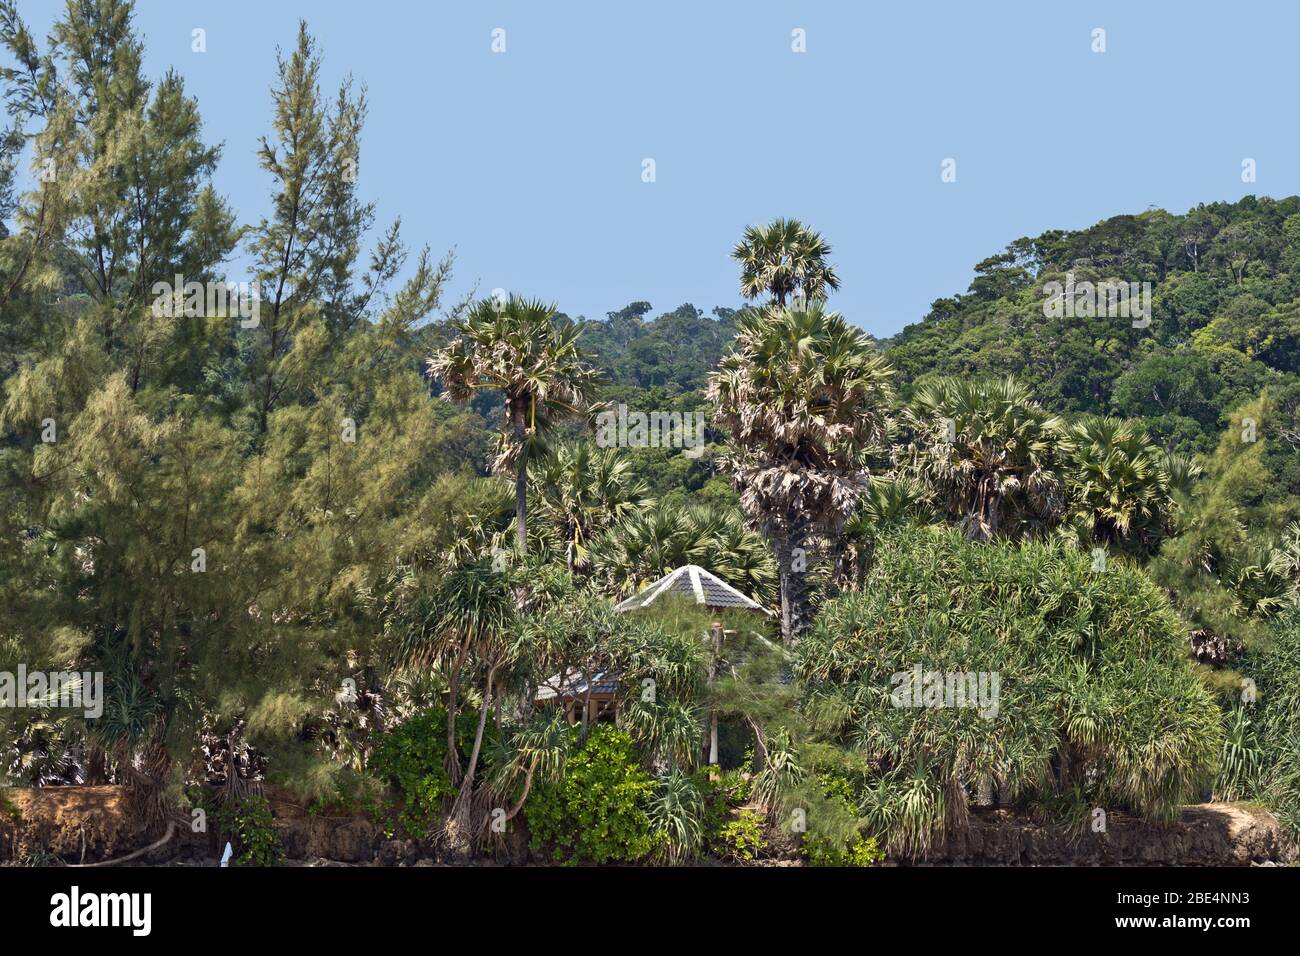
(0, 0), (1300, 865)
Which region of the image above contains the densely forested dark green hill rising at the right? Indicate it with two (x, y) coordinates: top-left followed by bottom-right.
(884, 196), (1300, 453)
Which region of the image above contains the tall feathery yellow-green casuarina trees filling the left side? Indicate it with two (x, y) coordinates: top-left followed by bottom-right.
(0, 3), (462, 803)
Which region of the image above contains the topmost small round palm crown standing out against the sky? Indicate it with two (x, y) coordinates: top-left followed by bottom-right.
(732, 219), (840, 306)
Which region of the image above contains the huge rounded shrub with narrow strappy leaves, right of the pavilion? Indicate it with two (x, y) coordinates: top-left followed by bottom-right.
(796, 528), (1223, 853)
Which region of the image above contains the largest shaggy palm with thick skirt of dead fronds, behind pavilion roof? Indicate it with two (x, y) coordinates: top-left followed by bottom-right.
(709, 304), (893, 643)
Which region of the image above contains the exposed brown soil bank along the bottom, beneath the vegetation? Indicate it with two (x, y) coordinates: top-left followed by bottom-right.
(0, 787), (1297, 866)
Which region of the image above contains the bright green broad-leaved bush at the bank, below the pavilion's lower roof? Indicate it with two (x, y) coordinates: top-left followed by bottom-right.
(524, 726), (657, 864)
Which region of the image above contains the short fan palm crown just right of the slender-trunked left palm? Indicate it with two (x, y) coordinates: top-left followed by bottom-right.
(530, 441), (654, 571)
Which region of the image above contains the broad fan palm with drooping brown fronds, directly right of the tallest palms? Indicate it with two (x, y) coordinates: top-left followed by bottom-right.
(904, 377), (1065, 541)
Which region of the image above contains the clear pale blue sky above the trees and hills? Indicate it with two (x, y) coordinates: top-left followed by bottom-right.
(12, 0), (1300, 336)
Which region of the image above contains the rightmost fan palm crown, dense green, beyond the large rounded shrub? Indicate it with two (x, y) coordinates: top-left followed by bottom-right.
(1061, 415), (1186, 550)
